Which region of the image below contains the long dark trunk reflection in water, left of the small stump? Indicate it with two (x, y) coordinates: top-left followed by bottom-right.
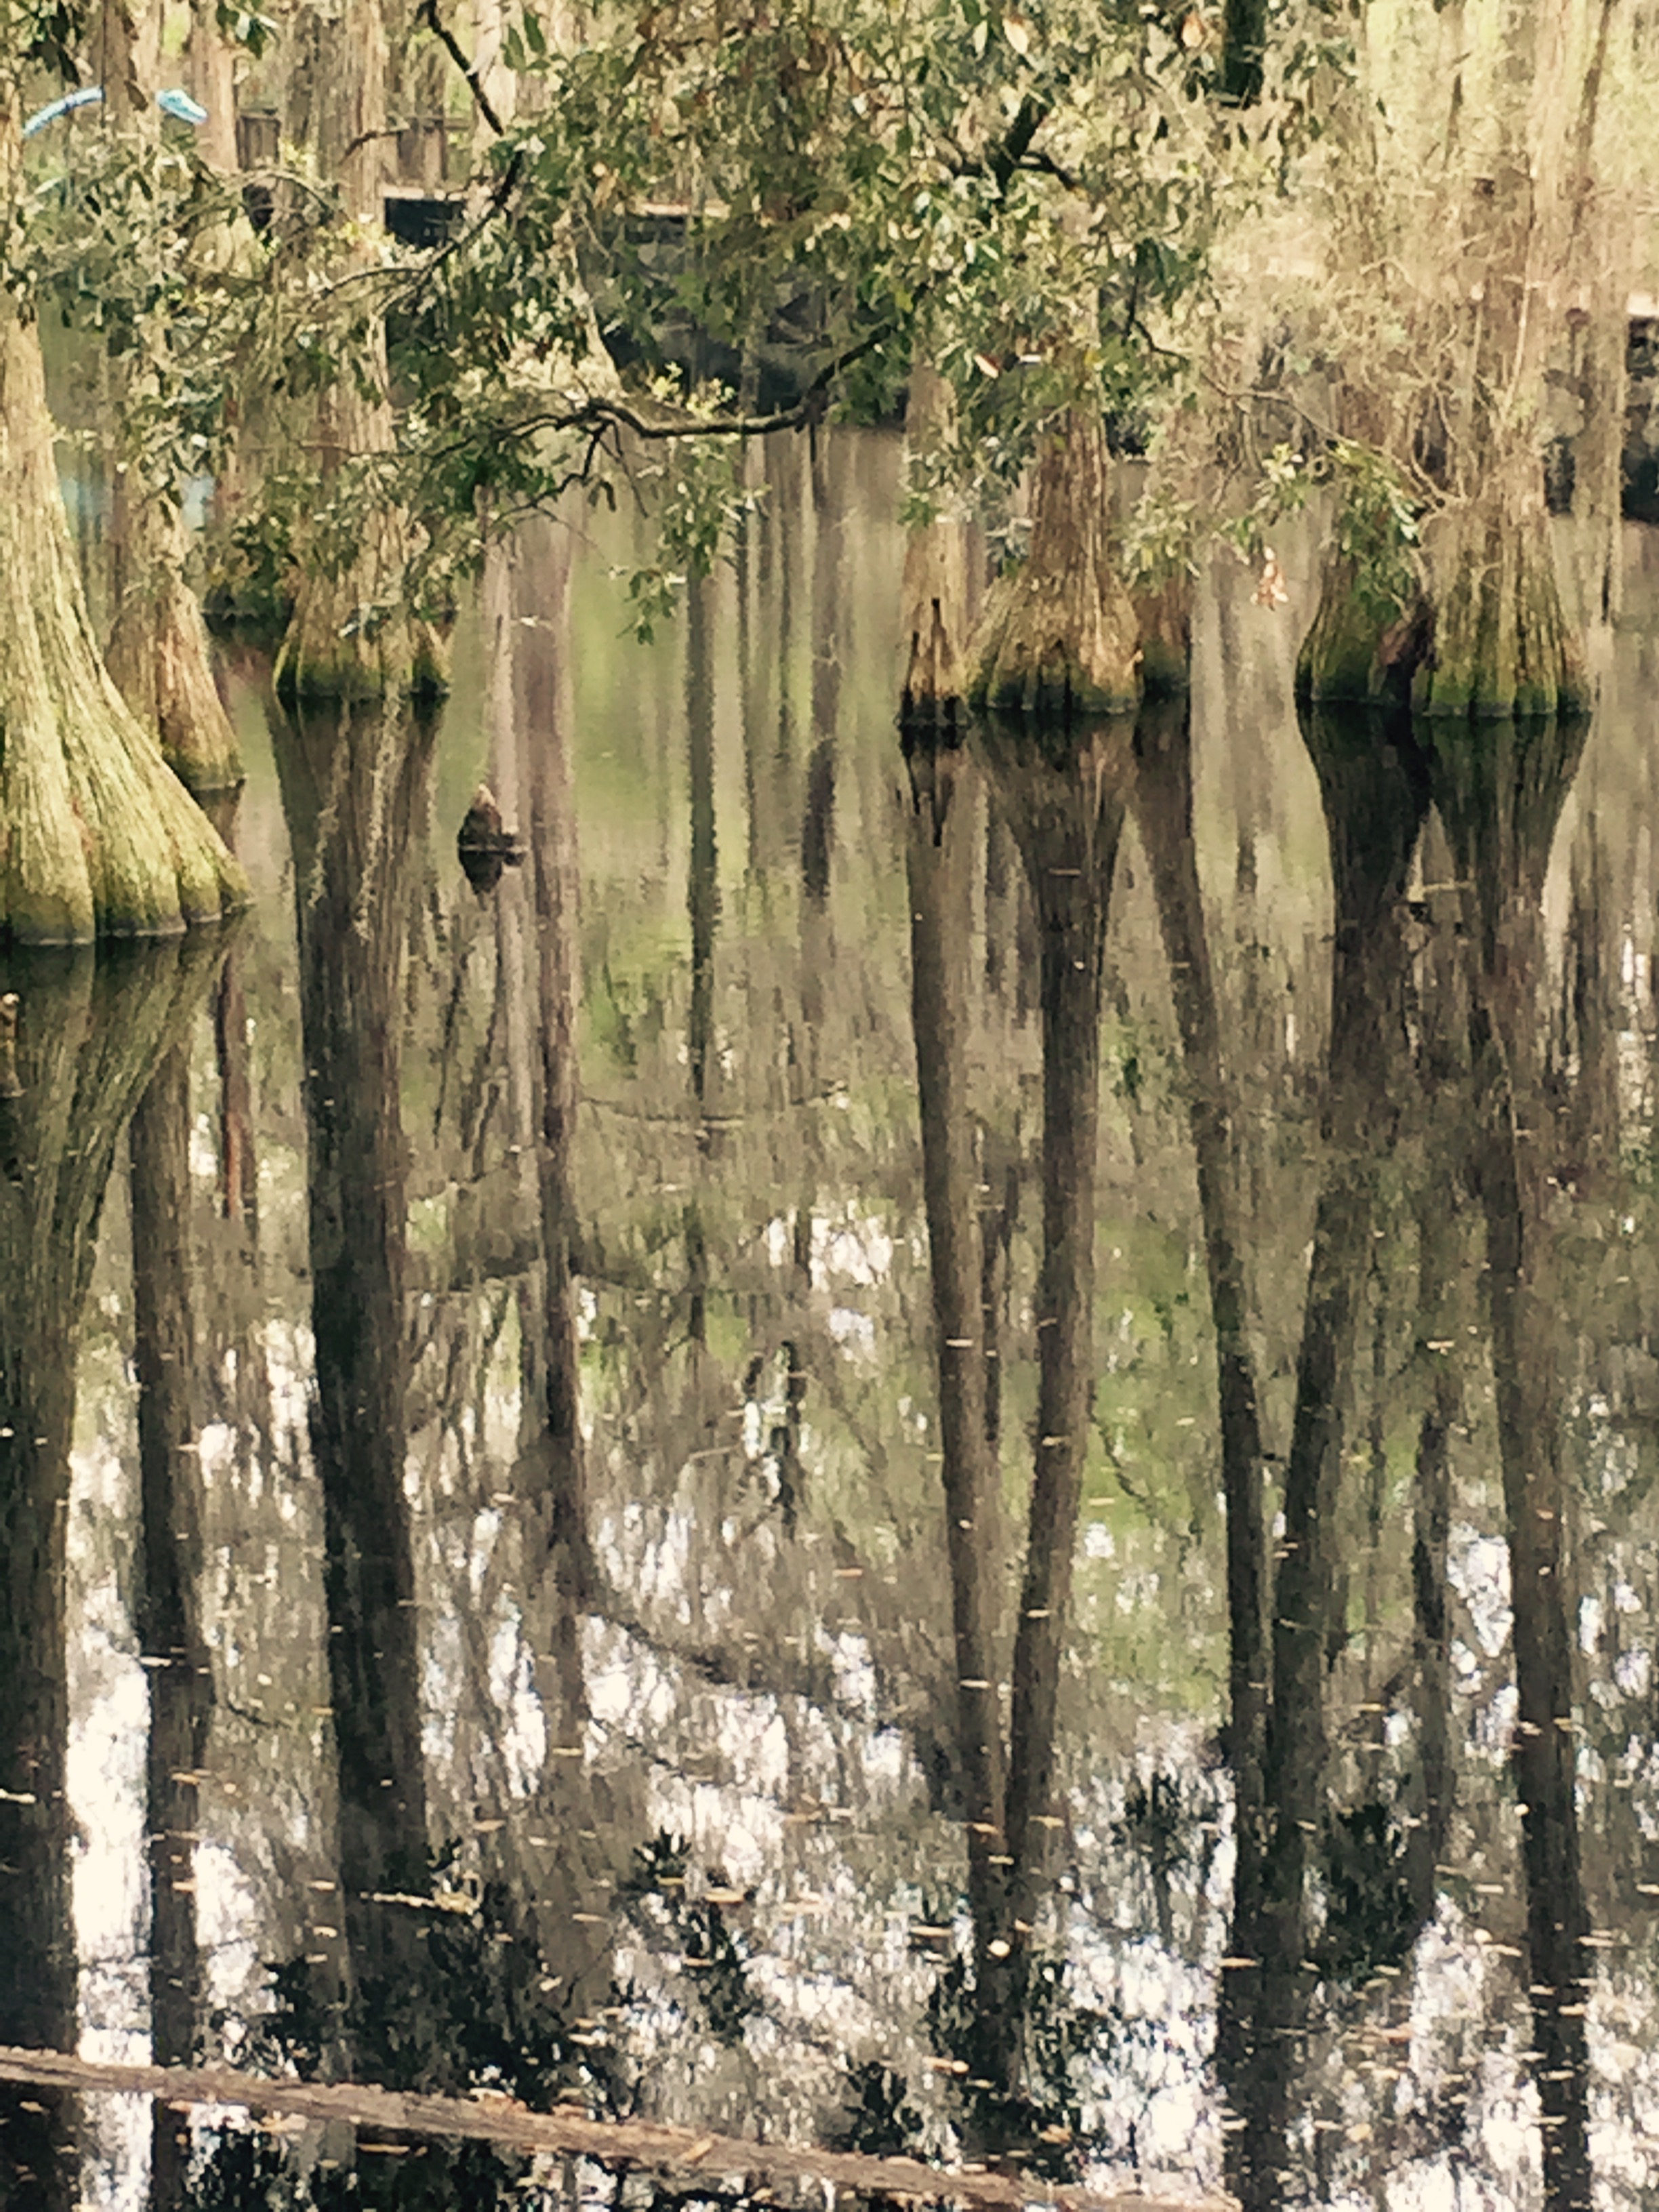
(272, 710), (436, 2079)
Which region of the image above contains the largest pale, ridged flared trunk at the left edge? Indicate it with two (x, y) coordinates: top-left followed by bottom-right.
(0, 84), (248, 945)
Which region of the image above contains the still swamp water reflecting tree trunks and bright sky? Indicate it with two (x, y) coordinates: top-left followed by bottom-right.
(0, 438), (1659, 2212)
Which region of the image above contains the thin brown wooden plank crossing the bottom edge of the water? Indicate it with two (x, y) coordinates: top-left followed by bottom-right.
(0, 2044), (1237, 2212)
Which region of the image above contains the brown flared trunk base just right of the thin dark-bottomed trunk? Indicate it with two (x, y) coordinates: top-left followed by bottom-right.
(969, 407), (1141, 723)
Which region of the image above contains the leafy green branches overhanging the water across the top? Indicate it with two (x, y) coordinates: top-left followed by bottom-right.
(11, 0), (1369, 637)
